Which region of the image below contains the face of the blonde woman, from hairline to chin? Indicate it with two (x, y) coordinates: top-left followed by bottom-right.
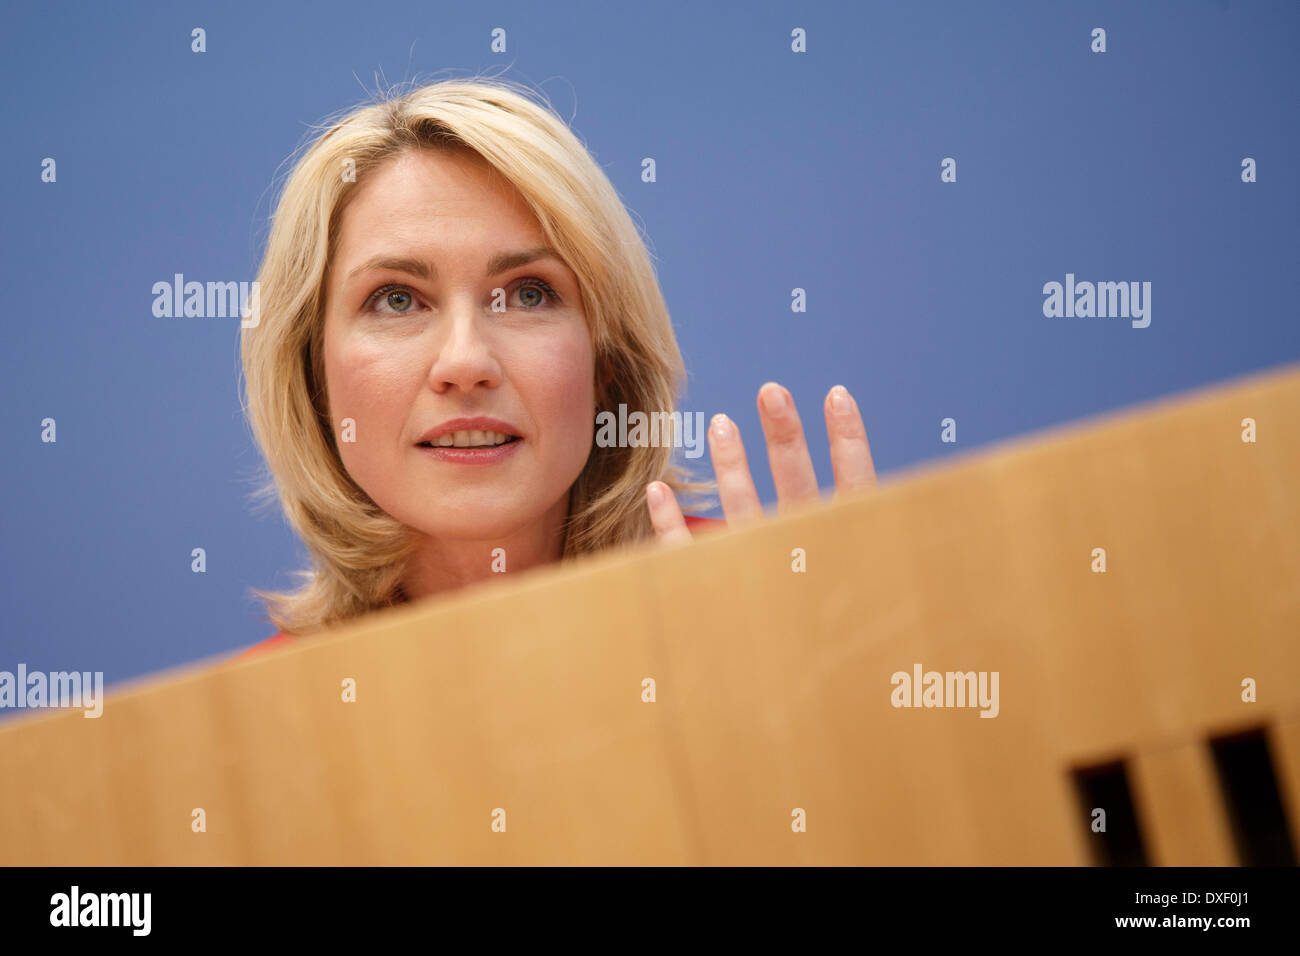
(325, 150), (595, 542)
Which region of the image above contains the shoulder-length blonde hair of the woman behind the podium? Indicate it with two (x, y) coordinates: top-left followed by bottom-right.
(241, 77), (712, 635)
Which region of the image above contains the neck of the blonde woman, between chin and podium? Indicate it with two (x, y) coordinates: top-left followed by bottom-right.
(402, 496), (568, 601)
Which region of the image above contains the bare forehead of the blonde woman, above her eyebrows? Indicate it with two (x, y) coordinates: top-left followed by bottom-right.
(338, 148), (542, 258)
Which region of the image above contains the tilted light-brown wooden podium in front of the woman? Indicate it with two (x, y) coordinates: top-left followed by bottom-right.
(0, 367), (1300, 865)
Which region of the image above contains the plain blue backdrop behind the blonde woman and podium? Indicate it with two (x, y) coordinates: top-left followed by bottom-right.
(0, 0), (1300, 683)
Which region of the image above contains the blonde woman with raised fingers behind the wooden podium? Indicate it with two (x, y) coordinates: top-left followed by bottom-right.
(242, 79), (875, 654)
